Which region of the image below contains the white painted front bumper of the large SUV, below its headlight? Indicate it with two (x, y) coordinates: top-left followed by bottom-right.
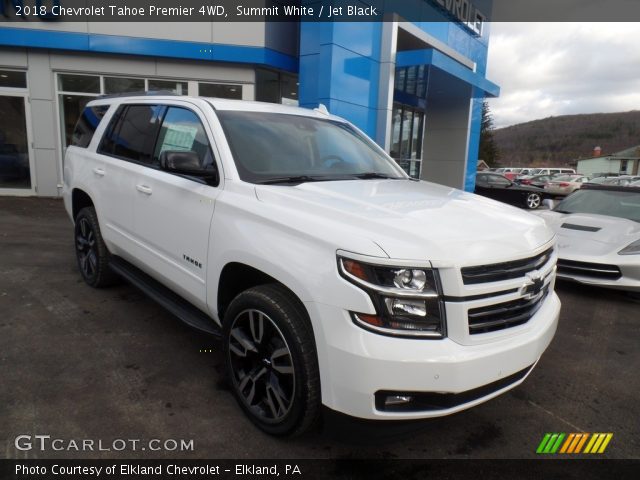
(306, 291), (560, 420)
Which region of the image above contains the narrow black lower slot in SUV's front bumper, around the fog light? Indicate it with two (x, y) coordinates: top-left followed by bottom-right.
(375, 365), (533, 412)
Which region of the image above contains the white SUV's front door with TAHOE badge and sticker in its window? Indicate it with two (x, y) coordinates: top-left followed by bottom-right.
(134, 102), (222, 310)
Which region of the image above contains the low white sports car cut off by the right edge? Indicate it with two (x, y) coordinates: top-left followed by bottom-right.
(536, 183), (640, 292)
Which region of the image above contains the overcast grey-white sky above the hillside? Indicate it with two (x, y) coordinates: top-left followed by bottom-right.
(487, 22), (640, 128)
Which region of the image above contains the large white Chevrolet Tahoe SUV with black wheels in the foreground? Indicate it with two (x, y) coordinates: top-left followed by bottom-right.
(64, 95), (560, 435)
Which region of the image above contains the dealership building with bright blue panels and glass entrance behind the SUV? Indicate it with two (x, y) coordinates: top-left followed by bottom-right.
(0, 0), (499, 196)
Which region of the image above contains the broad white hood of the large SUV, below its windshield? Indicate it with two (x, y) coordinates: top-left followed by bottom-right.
(256, 180), (553, 266)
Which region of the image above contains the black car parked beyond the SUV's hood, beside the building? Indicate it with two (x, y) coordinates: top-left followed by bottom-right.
(475, 172), (545, 210)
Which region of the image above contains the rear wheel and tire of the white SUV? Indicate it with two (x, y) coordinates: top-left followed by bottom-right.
(74, 207), (119, 288)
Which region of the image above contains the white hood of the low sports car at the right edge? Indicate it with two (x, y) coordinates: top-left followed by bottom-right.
(536, 211), (640, 257)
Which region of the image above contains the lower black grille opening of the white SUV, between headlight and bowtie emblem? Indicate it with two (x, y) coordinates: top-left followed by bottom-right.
(467, 284), (549, 335)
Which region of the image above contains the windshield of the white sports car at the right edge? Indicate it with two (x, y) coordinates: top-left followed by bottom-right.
(554, 187), (640, 222)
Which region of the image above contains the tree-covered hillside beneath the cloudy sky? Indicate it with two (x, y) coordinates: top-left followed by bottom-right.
(494, 110), (640, 166)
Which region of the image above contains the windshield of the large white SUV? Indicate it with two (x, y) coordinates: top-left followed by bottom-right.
(216, 110), (408, 183)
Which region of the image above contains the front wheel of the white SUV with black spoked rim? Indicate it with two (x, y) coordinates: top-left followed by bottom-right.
(223, 284), (320, 436)
